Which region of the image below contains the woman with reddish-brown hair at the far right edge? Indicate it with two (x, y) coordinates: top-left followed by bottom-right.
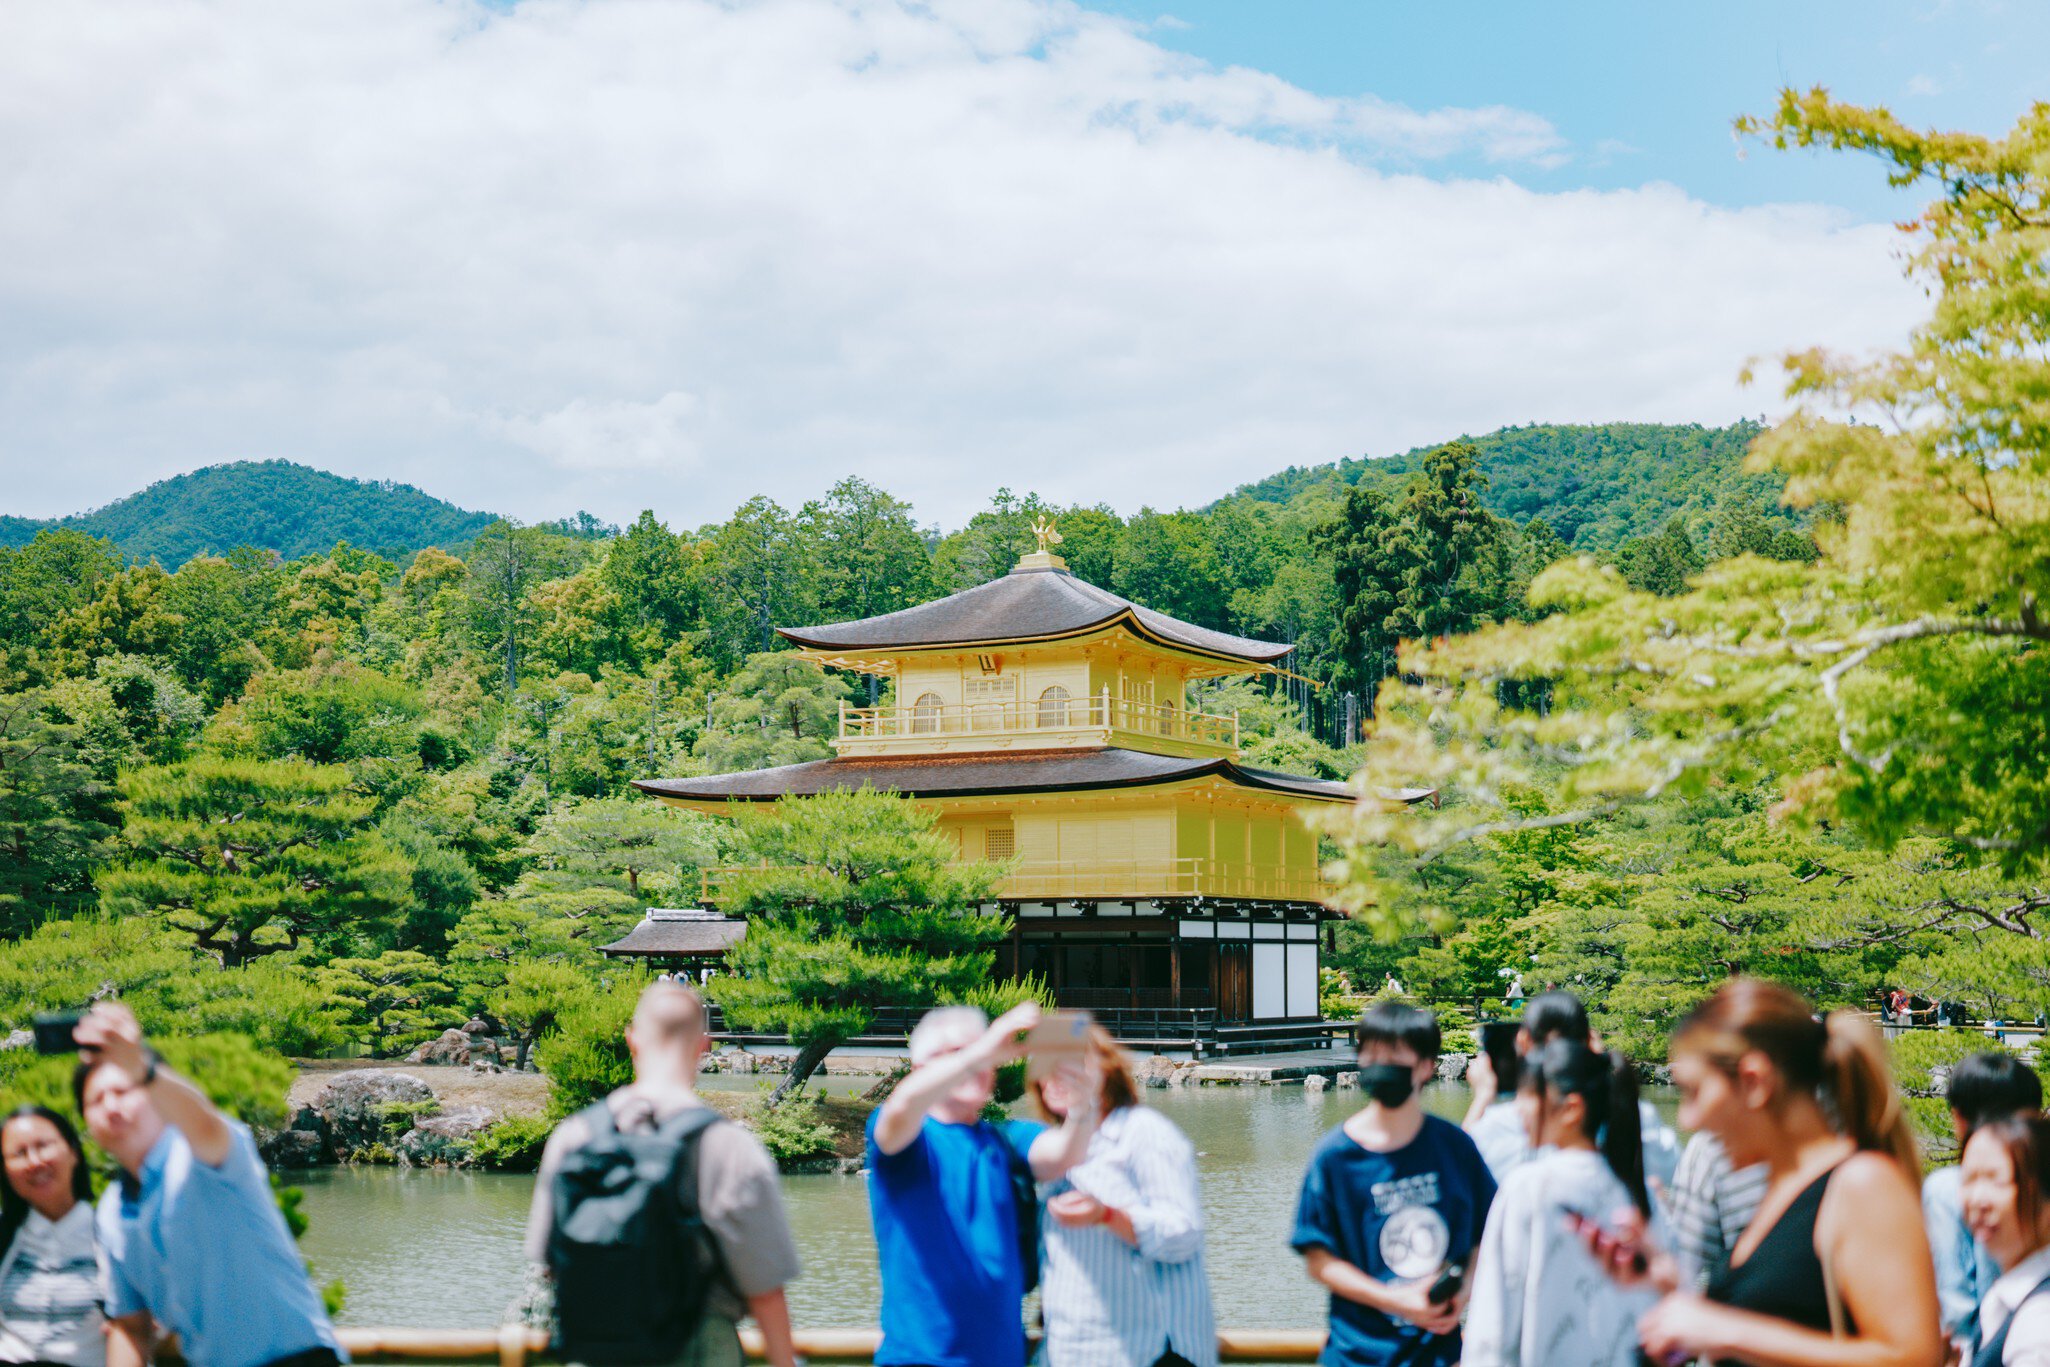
(1958, 1115), (2050, 1367)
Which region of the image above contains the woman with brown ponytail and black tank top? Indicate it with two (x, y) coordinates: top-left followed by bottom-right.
(1597, 978), (1943, 1367)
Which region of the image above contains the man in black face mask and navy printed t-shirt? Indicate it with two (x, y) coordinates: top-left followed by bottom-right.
(1289, 1002), (1494, 1367)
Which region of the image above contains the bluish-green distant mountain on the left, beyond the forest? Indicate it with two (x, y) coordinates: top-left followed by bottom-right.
(0, 461), (496, 570)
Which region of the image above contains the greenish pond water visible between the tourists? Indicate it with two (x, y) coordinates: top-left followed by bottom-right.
(293, 1078), (1671, 1328)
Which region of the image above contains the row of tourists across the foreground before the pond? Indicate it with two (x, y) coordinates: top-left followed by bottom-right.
(0, 980), (2050, 1367)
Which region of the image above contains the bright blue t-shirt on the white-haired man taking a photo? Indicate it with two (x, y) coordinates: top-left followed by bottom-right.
(867, 1111), (1043, 1367)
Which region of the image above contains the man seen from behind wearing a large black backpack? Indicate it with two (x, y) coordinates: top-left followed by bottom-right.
(527, 982), (797, 1367)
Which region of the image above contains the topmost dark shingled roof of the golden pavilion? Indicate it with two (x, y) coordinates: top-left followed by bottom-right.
(777, 568), (1289, 664)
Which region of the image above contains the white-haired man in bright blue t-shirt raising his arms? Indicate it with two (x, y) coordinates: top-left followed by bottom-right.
(867, 1002), (1101, 1367)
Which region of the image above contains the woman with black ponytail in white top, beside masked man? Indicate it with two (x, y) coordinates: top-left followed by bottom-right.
(1462, 1039), (1654, 1367)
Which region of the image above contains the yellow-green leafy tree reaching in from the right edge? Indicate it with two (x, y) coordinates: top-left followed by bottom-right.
(1343, 90), (2050, 934)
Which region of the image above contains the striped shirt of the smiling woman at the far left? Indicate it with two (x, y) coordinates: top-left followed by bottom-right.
(0, 1201), (107, 1367)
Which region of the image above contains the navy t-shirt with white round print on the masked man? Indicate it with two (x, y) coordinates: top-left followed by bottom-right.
(1289, 1115), (1494, 1367)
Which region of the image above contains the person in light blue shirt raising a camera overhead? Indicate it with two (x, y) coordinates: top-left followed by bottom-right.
(72, 1002), (344, 1367)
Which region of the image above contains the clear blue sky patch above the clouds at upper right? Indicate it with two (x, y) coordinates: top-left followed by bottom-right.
(1089, 0), (2050, 217)
